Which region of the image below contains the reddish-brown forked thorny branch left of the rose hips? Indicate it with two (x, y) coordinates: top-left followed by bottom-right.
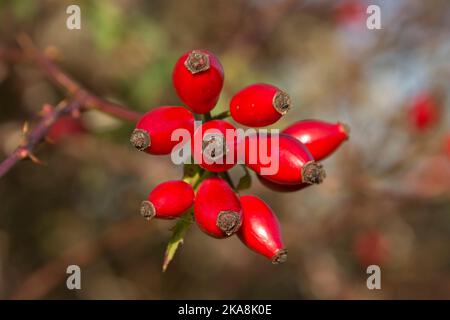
(0, 35), (141, 178)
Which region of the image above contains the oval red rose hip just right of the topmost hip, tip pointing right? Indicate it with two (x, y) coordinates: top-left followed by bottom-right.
(230, 83), (291, 127)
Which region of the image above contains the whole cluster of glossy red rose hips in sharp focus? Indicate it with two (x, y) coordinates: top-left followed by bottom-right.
(130, 50), (348, 263)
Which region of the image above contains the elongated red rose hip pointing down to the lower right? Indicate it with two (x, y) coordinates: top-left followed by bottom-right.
(238, 195), (287, 264)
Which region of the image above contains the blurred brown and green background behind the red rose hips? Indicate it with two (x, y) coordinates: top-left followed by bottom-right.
(0, 0), (450, 299)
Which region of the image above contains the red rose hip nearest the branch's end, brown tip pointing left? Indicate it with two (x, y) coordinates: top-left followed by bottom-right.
(130, 106), (195, 155)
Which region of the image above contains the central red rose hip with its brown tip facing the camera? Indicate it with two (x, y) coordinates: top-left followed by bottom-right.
(191, 120), (237, 172)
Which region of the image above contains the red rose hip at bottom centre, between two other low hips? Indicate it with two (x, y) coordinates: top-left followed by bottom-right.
(194, 177), (242, 238)
